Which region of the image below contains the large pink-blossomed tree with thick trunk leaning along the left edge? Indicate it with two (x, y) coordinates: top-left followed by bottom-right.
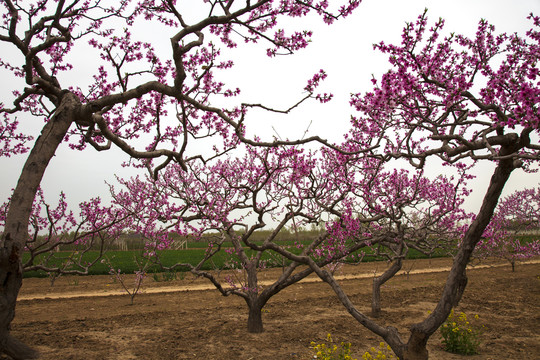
(0, 0), (359, 359)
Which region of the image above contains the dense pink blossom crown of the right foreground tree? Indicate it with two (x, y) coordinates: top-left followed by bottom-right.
(348, 12), (540, 167)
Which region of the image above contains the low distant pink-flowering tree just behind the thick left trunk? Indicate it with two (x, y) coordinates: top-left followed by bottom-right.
(0, 189), (130, 284)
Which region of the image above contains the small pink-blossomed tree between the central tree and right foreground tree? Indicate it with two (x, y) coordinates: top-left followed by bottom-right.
(316, 156), (469, 317)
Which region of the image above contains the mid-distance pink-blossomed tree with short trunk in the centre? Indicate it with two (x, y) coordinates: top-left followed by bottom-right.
(113, 148), (365, 333)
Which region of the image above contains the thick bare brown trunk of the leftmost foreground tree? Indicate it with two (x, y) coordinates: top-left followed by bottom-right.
(0, 94), (80, 359)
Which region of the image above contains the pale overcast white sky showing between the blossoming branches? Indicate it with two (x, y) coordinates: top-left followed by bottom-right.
(0, 0), (540, 222)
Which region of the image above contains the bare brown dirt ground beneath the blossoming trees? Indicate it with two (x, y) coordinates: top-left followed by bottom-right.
(4, 259), (540, 360)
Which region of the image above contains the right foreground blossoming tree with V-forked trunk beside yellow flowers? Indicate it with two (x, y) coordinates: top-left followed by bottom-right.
(291, 13), (540, 360)
